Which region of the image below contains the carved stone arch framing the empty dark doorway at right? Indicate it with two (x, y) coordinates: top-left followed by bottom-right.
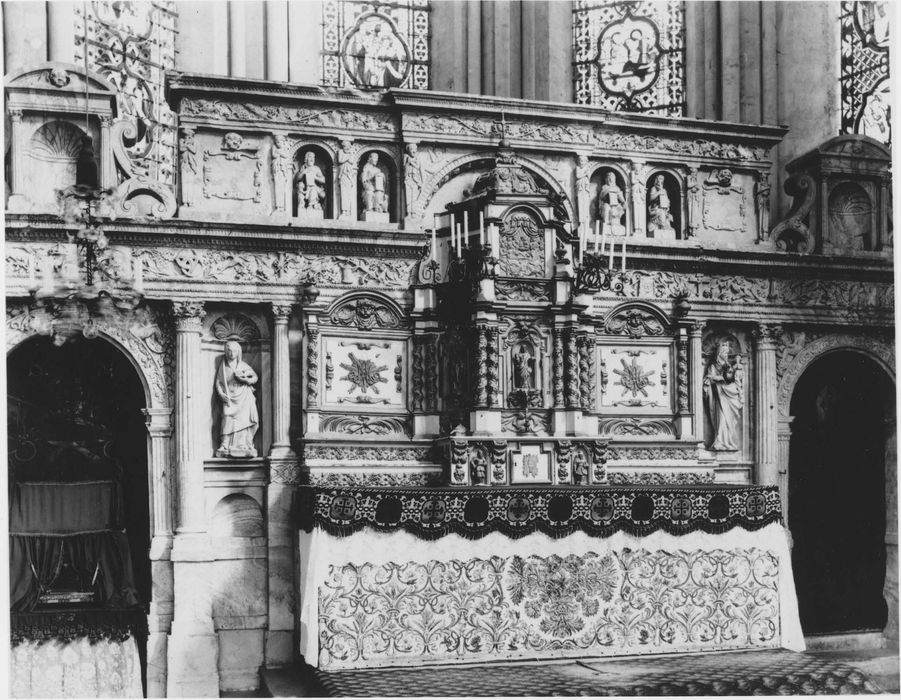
(777, 334), (898, 640)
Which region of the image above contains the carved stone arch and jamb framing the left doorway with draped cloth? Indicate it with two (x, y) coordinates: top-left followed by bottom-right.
(6, 301), (175, 697)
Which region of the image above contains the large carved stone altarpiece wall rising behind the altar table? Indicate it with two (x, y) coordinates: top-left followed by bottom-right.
(6, 67), (893, 694)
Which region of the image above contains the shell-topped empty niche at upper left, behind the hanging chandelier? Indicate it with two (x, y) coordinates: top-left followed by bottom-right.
(27, 121), (91, 203)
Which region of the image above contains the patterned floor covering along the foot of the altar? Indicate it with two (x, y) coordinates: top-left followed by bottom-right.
(263, 649), (899, 697)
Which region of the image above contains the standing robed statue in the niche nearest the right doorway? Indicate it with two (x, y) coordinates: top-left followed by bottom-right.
(704, 338), (744, 452)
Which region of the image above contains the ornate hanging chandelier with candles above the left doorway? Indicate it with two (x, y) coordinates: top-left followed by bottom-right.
(30, 185), (144, 345)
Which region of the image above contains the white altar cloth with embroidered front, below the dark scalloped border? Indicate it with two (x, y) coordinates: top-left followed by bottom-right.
(300, 523), (804, 669)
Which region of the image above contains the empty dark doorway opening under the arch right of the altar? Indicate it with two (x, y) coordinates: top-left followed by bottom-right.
(788, 351), (894, 634)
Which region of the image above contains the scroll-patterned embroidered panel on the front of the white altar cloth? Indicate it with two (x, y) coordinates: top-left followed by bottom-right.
(319, 548), (780, 669)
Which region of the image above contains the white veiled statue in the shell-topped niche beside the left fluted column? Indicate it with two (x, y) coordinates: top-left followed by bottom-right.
(216, 340), (260, 459)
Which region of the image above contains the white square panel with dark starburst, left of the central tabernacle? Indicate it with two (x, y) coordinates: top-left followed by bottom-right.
(322, 337), (407, 408)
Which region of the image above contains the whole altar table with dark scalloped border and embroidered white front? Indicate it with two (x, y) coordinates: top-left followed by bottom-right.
(300, 486), (804, 669)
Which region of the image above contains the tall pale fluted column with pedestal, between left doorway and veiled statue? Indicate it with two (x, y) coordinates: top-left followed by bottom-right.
(166, 301), (219, 697)
